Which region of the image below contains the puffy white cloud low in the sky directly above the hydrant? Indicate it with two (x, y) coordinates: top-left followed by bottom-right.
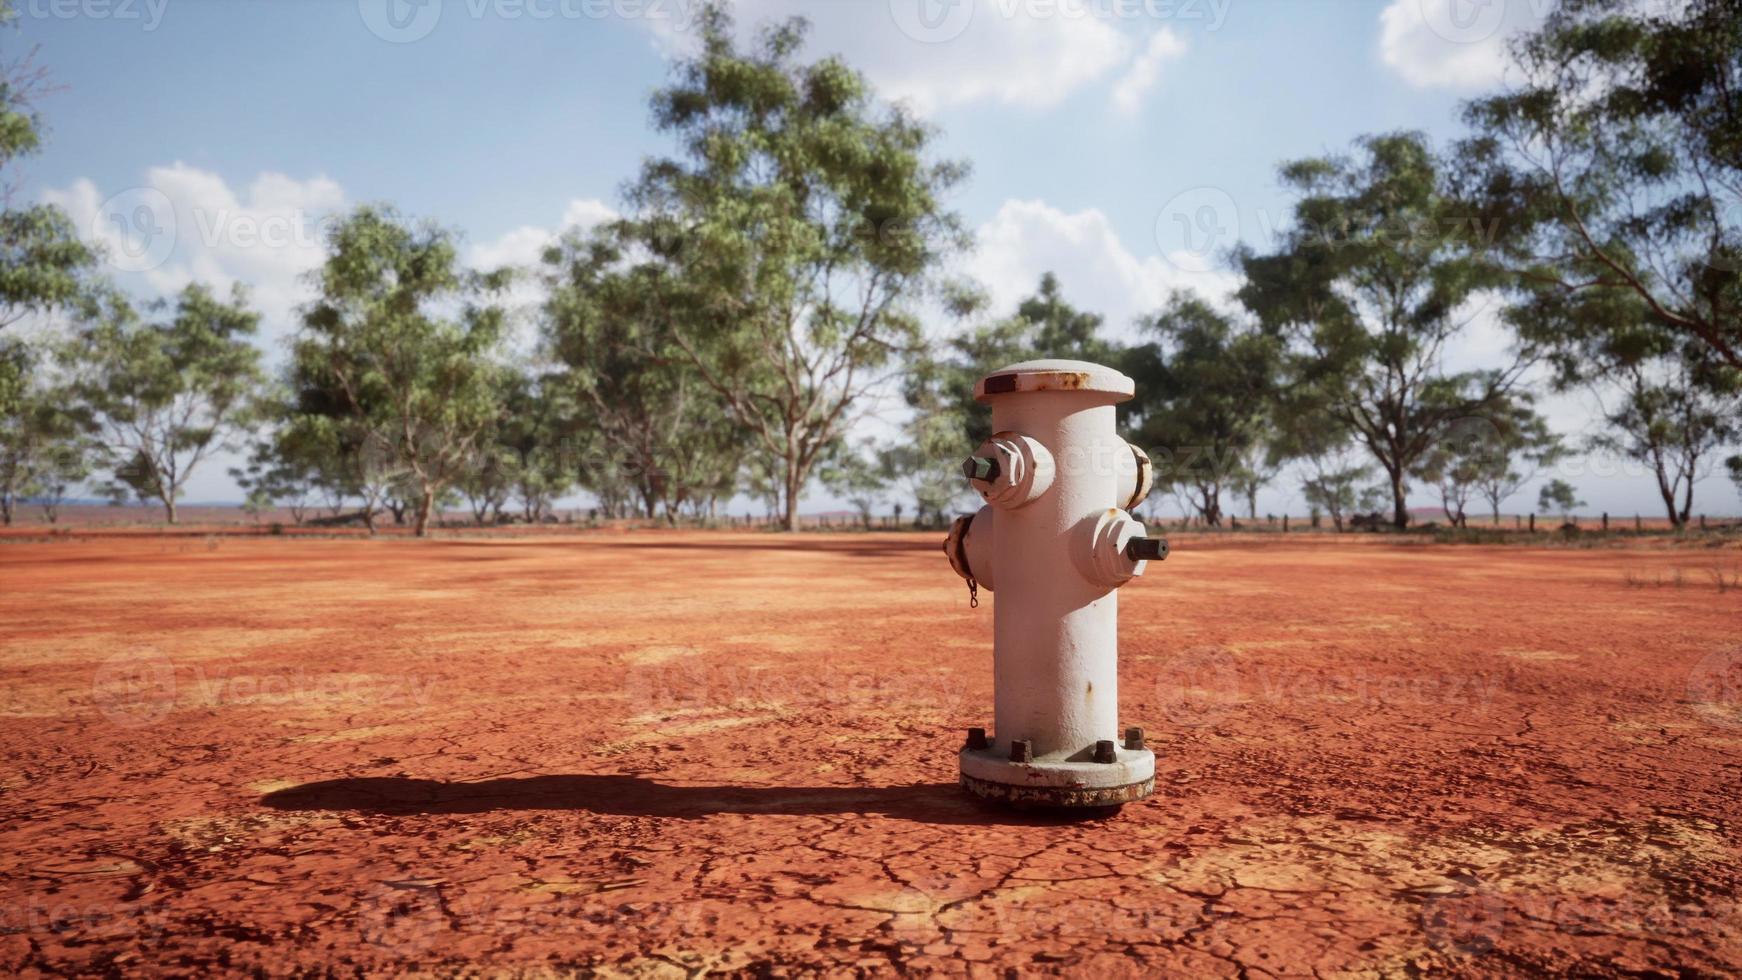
(965, 200), (1235, 339)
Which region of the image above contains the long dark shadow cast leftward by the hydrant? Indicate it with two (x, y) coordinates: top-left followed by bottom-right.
(260, 775), (1113, 825)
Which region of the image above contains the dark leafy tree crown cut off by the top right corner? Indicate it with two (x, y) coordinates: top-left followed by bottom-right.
(1462, 0), (1742, 371)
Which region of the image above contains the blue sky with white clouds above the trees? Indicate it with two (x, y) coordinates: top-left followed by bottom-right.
(3, 0), (1735, 513)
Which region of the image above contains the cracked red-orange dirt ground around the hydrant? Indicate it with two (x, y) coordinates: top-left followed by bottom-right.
(0, 533), (1742, 977)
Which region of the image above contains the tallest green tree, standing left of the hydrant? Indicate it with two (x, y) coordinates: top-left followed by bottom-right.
(631, 3), (967, 529)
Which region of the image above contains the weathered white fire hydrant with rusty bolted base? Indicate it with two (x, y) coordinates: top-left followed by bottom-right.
(944, 360), (1167, 808)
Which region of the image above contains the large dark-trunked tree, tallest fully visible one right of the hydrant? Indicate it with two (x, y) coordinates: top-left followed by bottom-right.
(1237, 132), (1526, 527)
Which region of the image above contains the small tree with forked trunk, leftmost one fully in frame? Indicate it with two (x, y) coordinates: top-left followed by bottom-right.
(66, 284), (263, 524)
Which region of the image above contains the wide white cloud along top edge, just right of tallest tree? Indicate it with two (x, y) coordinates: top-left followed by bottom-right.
(641, 0), (1142, 113)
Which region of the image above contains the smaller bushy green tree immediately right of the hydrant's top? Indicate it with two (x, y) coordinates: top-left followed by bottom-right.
(1124, 292), (1282, 527)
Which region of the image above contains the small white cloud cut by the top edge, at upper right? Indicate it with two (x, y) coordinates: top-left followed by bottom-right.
(1380, 0), (1550, 91)
